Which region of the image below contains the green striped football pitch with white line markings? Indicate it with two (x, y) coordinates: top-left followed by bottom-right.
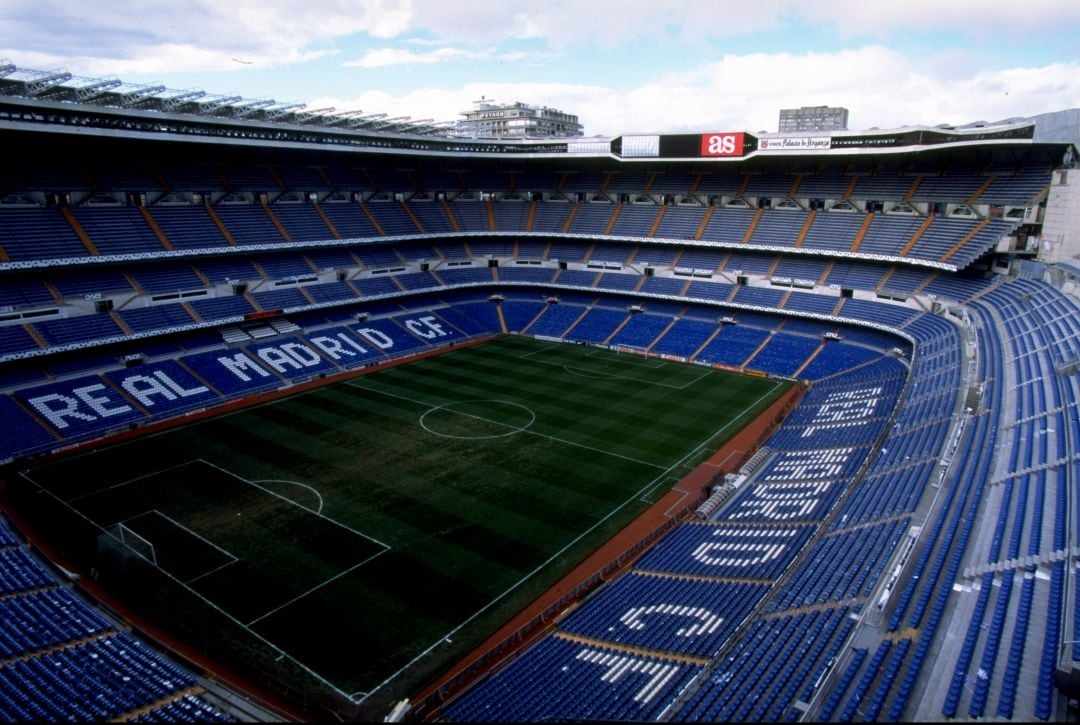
(14, 336), (791, 714)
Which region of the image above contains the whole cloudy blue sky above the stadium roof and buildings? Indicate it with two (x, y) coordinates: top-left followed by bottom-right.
(0, 0), (1080, 136)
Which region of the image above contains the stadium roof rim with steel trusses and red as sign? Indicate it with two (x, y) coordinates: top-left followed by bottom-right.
(0, 61), (1071, 162)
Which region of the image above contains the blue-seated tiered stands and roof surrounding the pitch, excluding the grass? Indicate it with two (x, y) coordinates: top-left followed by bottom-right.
(0, 67), (1080, 722)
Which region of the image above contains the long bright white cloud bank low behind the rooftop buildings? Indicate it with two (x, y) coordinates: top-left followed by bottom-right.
(311, 45), (1080, 136)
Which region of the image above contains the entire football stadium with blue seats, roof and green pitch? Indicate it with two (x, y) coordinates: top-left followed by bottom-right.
(0, 58), (1080, 722)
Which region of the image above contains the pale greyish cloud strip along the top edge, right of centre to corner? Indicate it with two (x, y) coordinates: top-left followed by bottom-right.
(409, 0), (1080, 49)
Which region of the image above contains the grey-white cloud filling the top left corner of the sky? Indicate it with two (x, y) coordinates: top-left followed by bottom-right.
(0, 0), (411, 76)
